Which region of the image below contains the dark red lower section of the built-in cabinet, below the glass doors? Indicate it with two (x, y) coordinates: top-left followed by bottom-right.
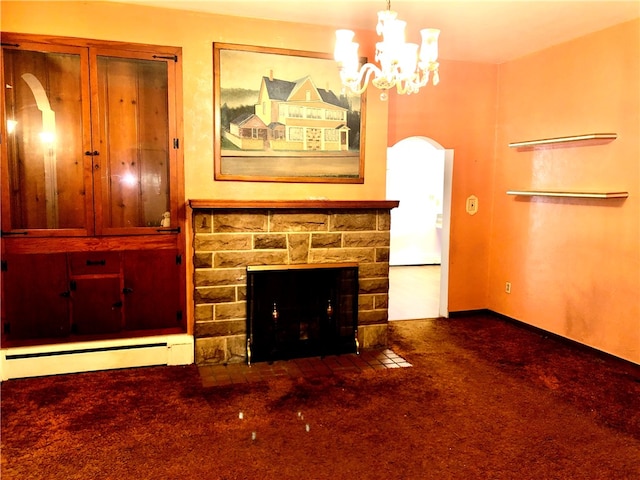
(3, 250), (184, 341)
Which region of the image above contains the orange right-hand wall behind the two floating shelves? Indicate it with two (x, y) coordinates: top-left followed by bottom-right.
(487, 20), (640, 363)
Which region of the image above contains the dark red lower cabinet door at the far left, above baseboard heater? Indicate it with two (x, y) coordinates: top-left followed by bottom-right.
(2, 253), (70, 340)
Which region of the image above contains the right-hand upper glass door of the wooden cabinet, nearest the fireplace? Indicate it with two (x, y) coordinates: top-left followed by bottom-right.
(92, 51), (175, 234)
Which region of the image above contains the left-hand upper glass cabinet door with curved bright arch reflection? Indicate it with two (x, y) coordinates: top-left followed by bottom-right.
(2, 44), (93, 235)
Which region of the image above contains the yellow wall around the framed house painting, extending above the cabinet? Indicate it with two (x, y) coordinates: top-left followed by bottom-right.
(0, 1), (388, 200)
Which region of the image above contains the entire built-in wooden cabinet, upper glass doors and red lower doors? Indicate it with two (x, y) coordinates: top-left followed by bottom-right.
(0, 33), (185, 342)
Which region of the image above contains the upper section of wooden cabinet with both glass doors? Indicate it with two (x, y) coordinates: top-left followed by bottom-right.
(2, 34), (180, 236)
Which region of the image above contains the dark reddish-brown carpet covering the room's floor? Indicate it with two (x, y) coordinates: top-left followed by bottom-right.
(0, 314), (640, 480)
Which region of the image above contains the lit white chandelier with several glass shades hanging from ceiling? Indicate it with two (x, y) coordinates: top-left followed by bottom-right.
(334, 0), (440, 100)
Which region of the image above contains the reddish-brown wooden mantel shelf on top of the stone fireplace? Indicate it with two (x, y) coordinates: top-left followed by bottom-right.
(189, 199), (400, 210)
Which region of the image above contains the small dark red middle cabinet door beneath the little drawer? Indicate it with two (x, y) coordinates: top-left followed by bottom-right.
(71, 275), (123, 335)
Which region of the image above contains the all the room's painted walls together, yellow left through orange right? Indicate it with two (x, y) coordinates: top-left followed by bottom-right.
(0, 1), (640, 363)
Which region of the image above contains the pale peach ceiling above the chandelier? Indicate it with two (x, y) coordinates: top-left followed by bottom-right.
(109, 0), (640, 63)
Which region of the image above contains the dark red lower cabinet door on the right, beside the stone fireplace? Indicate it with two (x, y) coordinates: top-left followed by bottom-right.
(123, 250), (184, 330)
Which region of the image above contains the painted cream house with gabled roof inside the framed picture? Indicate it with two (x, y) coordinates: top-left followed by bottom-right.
(225, 75), (350, 152)
